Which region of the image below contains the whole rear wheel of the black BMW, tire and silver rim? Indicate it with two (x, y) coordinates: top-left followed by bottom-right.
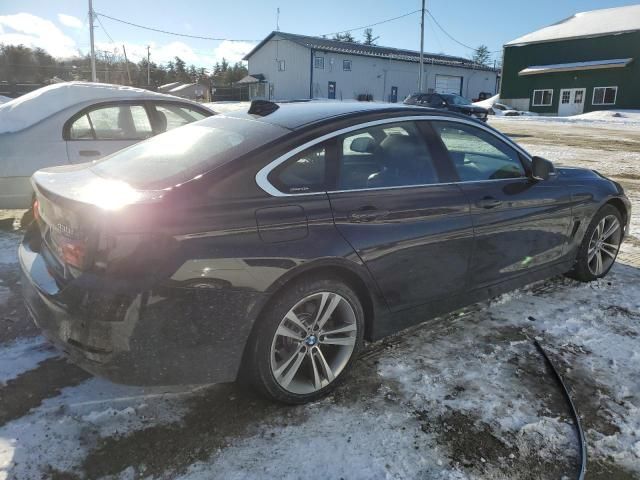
(244, 278), (364, 404)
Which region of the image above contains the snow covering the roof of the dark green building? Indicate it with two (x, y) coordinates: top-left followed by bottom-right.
(507, 5), (640, 46)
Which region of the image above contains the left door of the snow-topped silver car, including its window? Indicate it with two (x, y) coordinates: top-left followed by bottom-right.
(63, 102), (153, 163)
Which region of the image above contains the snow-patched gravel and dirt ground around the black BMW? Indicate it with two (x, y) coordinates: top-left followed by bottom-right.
(0, 119), (640, 480)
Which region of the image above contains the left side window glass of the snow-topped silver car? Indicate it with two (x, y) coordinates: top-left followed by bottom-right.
(69, 105), (153, 140)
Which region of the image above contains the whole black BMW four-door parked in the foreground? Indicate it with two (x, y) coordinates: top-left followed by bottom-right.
(19, 102), (630, 403)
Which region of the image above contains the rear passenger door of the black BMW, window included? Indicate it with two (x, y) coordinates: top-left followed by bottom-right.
(329, 119), (473, 311)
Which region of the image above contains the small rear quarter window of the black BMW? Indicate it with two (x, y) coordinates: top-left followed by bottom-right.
(269, 145), (326, 193)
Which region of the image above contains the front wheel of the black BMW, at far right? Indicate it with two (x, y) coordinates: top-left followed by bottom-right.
(569, 205), (623, 282)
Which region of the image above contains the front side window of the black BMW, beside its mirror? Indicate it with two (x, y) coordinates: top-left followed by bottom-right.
(433, 122), (526, 182)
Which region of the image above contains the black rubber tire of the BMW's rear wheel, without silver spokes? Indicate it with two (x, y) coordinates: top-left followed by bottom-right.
(242, 277), (364, 404)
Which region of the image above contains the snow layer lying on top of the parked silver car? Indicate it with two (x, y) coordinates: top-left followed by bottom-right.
(0, 82), (168, 134)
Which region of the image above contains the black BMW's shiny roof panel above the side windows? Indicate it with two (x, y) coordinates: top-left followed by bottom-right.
(223, 101), (469, 130)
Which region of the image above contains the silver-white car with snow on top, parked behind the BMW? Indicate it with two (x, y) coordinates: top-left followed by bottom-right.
(0, 82), (215, 209)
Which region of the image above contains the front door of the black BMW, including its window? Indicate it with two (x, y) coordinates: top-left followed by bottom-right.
(432, 121), (571, 286)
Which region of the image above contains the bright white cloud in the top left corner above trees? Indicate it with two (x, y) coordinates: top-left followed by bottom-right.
(0, 13), (78, 57)
